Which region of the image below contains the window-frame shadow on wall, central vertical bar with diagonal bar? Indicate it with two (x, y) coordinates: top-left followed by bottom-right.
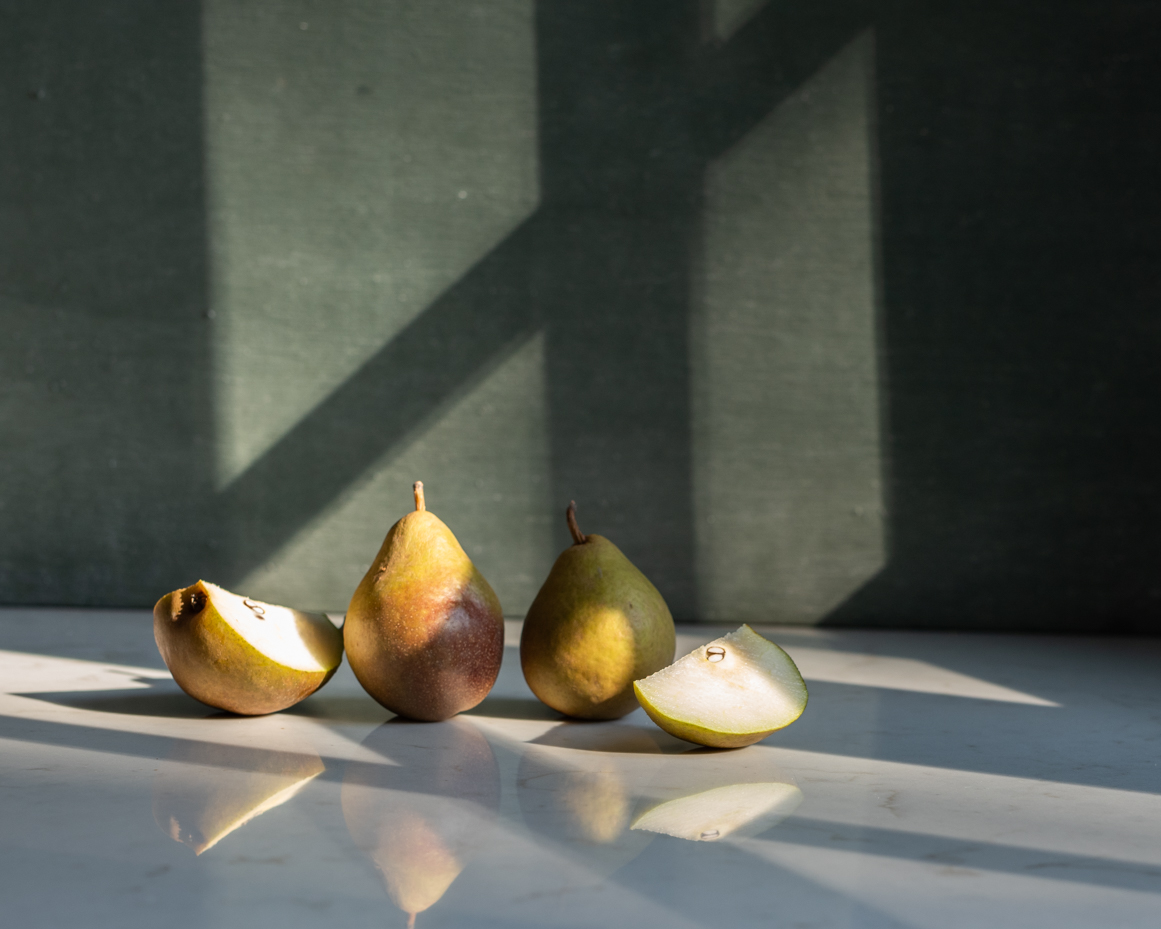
(211, 2), (866, 618)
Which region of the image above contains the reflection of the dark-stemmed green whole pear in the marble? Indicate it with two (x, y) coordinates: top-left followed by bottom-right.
(517, 723), (663, 876)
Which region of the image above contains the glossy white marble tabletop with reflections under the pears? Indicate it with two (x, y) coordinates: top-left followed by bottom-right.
(0, 608), (1161, 929)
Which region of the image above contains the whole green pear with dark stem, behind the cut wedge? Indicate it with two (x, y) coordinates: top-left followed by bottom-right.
(520, 502), (677, 719)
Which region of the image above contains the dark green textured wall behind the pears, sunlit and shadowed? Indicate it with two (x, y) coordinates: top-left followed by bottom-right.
(0, 0), (1161, 632)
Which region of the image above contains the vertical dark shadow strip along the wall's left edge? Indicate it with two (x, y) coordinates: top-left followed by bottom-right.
(0, 0), (215, 604)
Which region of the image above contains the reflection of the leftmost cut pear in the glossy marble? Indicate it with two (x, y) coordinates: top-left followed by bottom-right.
(153, 741), (326, 855)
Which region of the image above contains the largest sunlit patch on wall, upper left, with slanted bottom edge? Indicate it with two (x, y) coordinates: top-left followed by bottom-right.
(203, 0), (539, 488)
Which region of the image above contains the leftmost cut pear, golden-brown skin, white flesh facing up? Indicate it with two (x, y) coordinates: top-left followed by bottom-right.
(153, 581), (342, 715)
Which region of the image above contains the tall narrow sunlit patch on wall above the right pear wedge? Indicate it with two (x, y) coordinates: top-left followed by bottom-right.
(691, 30), (886, 622)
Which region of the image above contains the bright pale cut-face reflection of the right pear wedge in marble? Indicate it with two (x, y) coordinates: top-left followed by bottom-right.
(633, 784), (802, 842)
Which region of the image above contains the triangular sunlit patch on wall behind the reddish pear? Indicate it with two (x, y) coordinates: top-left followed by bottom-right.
(243, 334), (555, 614)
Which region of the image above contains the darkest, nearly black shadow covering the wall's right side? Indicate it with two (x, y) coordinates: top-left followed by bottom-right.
(828, 2), (1161, 633)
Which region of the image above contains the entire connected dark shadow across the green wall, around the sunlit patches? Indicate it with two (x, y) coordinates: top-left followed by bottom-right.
(0, 0), (1161, 631)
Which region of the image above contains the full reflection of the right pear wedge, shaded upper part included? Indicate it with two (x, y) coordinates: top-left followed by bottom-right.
(632, 749), (803, 842)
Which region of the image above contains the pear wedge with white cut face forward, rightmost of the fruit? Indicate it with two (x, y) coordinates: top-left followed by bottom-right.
(633, 626), (807, 748)
